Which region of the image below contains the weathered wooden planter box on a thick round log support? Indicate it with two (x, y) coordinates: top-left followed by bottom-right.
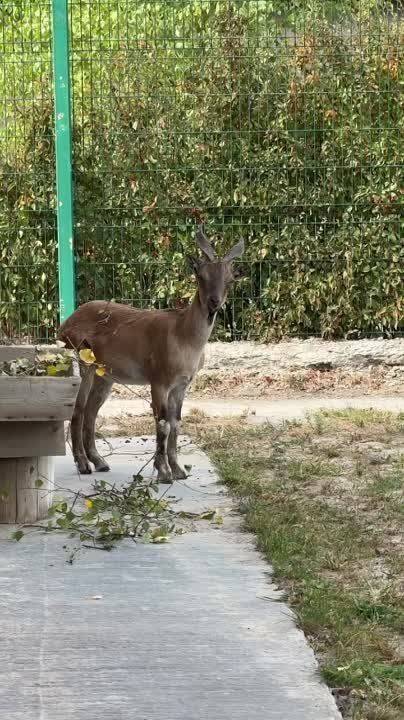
(0, 345), (80, 524)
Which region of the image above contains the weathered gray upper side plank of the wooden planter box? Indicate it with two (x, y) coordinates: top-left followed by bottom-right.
(0, 376), (80, 421)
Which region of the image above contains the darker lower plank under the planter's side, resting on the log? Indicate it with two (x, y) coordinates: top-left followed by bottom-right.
(0, 420), (66, 458)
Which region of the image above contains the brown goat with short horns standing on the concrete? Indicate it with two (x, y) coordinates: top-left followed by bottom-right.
(59, 228), (244, 482)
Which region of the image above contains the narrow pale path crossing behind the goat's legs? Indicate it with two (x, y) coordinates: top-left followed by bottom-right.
(100, 390), (404, 423)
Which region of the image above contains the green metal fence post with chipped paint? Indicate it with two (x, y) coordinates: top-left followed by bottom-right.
(52, 0), (75, 322)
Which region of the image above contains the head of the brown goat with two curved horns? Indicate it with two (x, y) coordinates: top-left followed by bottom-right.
(188, 226), (244, 320)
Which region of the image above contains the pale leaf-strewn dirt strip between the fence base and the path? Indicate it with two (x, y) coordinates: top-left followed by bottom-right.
(113, 338), (404, 399)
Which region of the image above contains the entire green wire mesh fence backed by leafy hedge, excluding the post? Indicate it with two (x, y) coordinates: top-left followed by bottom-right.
(0, 0), (404, 339)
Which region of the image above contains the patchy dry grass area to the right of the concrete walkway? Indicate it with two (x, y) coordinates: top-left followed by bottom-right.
(193, 410), (404, 720)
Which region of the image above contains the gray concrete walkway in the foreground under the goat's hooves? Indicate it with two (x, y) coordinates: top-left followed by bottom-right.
(0, 439), (340, 720)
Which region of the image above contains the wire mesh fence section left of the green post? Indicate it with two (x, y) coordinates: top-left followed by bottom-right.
(0, 0), (57, 339)
